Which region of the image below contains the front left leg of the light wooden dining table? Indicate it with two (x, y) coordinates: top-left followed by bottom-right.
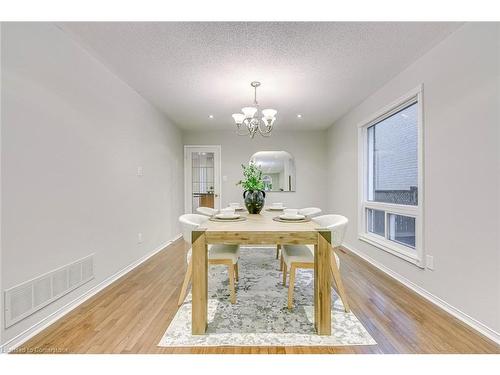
(191, 231), (208, 335)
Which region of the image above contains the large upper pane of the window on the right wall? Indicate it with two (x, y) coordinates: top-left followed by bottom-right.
(367, 103), (418, 206)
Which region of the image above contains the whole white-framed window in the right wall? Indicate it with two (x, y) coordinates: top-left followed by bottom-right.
(359, 87), (423, 266)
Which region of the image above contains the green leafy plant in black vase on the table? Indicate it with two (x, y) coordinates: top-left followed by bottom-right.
(236, 162), (266, 214)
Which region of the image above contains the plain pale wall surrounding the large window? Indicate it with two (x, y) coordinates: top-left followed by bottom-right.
(328, 23), (500, 333)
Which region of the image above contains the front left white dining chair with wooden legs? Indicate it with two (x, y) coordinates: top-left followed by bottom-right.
(178, 214), (240, 306)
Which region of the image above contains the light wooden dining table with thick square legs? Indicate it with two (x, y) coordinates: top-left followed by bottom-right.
(191, 209), (336, 335)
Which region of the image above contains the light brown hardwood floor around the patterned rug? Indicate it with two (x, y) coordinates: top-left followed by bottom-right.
(12, 240), (500, 354)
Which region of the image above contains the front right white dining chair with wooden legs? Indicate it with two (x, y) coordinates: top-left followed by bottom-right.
(281, 215), (350, 312)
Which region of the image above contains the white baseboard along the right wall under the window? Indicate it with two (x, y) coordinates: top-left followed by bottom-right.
(342, 243), (500, 345)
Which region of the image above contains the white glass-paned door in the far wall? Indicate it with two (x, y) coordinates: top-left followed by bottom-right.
(184, 146), (221, 213)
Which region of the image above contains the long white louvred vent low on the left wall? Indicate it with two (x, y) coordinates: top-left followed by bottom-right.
(4, 254), (94, 327)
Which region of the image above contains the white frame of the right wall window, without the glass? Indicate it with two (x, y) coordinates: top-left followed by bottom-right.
(358, 84), (424, 268)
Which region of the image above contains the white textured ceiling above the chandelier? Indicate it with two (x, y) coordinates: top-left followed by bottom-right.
(59, 22), (460, 130)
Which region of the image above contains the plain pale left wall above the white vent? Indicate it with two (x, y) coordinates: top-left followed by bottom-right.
(1, 23), (183, 342)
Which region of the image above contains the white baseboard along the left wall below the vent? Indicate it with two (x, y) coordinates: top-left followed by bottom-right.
(0, 234), (182, 353)
